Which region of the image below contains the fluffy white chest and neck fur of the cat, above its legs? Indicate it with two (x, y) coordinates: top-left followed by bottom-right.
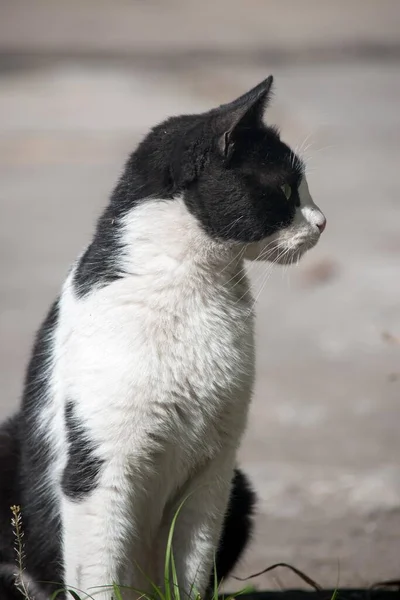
(54, 200), (254, 487)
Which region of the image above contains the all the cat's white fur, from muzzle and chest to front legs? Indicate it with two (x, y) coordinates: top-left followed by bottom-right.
(43, 189), (321, 599)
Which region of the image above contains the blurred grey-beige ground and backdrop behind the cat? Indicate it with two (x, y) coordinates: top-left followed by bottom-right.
(0, 0), (400, 588)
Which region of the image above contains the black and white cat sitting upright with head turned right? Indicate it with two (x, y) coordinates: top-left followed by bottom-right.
(0, 77), (325, 600)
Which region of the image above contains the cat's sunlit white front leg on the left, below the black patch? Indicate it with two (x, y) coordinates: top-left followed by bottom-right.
(62, 460), (161, 600)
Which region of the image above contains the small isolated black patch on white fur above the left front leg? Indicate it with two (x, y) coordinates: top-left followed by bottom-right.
(61, 402), (103, 500)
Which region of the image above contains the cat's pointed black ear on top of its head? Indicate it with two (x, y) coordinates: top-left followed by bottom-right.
(217, 75), (273, 158)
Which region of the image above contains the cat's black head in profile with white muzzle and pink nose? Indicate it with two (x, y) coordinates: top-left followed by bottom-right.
(132, 77), (326, 263)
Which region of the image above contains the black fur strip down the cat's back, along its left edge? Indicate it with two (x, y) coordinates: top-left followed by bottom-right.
(16, 301), (63, 594)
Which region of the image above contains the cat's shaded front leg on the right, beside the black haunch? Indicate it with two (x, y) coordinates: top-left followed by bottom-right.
(159, 450), (236, 598)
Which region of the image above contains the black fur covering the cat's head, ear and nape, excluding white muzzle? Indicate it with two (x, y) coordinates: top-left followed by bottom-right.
(74, 77), (304, 297)
